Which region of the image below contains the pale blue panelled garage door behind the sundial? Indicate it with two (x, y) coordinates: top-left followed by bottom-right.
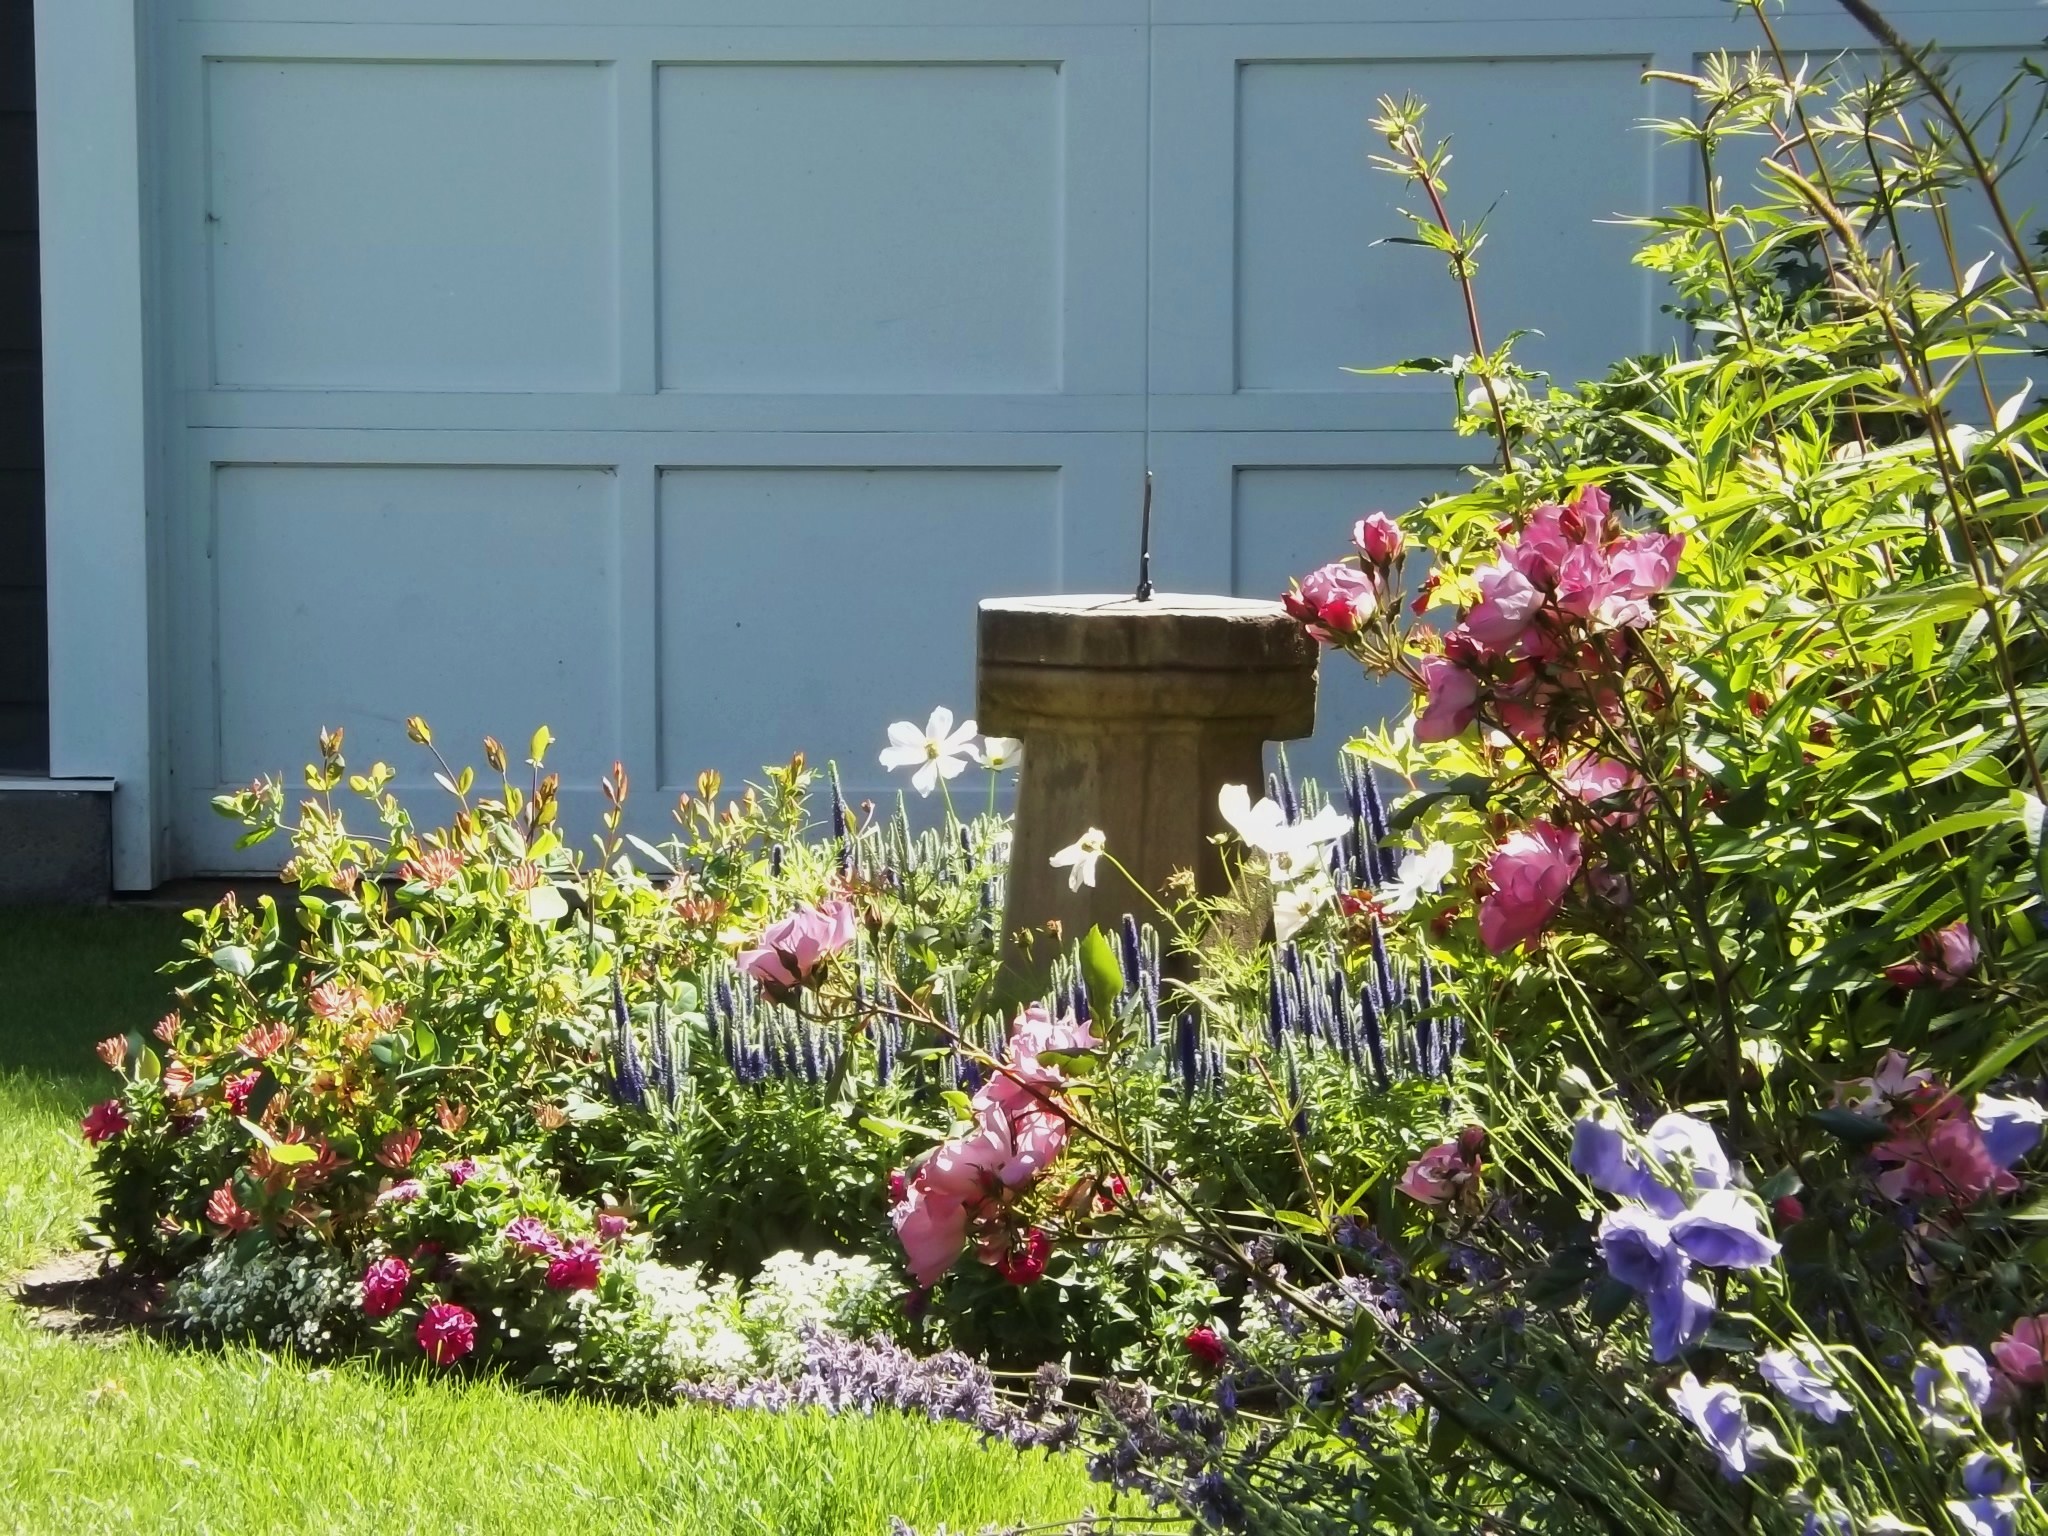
(152, 0), (2025, 872)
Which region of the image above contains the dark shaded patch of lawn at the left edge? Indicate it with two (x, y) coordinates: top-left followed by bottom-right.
(0, 907), (188, 1079)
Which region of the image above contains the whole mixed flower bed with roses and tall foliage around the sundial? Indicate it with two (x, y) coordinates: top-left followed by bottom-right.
(64, 12), (2048, 1536)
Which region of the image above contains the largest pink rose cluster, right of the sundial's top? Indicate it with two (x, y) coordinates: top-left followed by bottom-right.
(1415, 485), (1686, 741)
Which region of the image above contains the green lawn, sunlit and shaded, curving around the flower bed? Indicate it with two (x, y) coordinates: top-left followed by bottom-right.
(0, 909), (1096, 1536)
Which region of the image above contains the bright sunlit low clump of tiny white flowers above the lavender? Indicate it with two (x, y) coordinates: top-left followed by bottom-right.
(633, 1251), (901, 1380)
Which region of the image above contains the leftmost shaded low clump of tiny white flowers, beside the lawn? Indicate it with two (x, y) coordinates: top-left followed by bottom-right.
(170, 1245), (360, 1356)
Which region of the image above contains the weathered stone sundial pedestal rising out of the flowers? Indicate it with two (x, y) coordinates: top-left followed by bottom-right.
(975, 592), (1317, 958)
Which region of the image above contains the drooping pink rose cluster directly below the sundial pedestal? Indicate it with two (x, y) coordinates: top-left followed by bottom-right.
(891, 1004), (1102, 1286)
